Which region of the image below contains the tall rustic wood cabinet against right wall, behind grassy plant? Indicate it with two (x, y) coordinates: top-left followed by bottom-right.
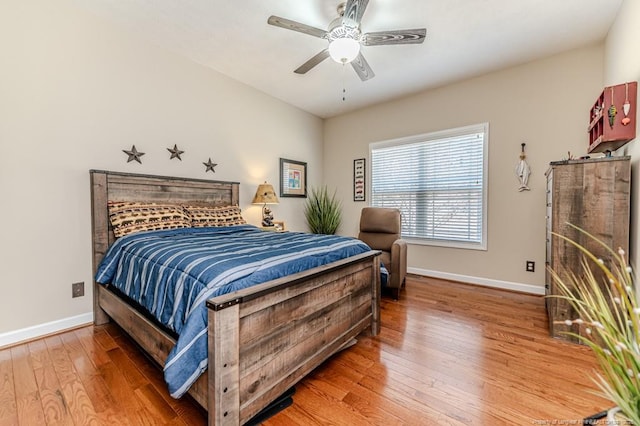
(545, 157), (631, 341)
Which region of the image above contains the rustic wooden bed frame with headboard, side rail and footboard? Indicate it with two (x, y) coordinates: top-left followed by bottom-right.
(90, 170), (380, 424)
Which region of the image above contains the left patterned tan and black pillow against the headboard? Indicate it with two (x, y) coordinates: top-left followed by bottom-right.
(108, 201), (191, 237)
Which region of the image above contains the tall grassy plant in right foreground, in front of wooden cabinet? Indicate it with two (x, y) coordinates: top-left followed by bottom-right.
(551, 225), (640, 425)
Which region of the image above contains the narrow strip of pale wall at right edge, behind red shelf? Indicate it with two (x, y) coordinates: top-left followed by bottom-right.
(603, 0), (640, 272)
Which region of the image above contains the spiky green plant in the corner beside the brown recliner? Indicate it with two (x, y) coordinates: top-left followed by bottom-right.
(304, 186), (342, 234)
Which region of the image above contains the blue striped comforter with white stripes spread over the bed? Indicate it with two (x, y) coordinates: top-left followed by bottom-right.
(96, 225), (370, 398)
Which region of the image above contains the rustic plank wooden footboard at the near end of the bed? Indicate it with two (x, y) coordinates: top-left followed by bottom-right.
(207, 252), (380, 425)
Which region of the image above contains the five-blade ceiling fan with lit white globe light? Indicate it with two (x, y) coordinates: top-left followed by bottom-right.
(267, 0), (427, 81)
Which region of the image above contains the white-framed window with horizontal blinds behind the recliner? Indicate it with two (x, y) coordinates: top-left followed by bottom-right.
(369, 123), (489, 250)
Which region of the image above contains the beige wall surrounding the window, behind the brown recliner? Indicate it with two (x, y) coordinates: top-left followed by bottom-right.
(324, 45), (603, 293)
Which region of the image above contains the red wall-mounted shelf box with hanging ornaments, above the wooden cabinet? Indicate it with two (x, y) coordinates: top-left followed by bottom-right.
(588, 81), (638, 153)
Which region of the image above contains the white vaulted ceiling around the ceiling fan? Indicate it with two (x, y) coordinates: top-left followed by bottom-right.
(75, 0), (622, 118)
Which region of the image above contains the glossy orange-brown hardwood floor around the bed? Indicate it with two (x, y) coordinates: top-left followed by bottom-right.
(0, 276), (611, 426)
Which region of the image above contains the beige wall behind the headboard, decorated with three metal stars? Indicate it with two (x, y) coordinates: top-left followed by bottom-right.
(0, 0), (323, 340)
